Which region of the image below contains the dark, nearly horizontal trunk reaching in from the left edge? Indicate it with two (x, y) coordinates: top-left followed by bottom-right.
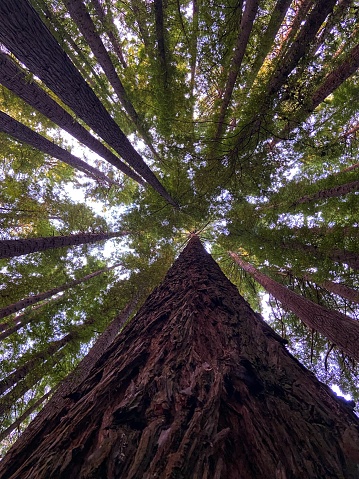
(0, 232), (128, 259)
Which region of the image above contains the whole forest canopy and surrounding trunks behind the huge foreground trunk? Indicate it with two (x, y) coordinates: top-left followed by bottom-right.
(0, 0), (359, 456)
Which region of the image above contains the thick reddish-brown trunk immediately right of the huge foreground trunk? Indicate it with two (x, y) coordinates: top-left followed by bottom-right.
(230, 252), (359, 361)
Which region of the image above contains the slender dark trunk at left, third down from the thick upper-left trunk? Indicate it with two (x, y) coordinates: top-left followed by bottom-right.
(0, 111), (118, 185)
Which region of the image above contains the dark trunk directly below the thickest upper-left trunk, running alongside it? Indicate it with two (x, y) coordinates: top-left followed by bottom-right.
(0, 52), (144, 185)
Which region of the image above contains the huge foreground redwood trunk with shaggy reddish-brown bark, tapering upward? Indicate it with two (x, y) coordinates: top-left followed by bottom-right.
(0, 235), (359, 479)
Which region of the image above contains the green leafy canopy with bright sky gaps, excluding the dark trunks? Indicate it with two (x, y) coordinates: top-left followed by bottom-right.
(0, 0), (359, 450)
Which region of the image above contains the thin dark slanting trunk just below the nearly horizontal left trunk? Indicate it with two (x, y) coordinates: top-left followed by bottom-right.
(0, 263), (120, 320)
